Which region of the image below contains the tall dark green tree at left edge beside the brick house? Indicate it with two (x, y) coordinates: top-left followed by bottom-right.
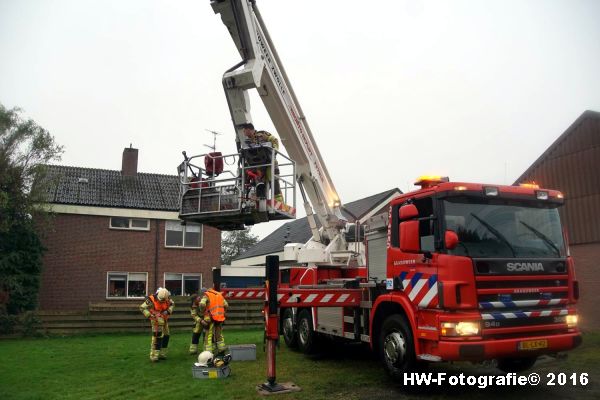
(0, 104), (63, 328)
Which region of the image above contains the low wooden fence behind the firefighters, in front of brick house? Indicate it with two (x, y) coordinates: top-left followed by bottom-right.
(38, 297), (264, 334)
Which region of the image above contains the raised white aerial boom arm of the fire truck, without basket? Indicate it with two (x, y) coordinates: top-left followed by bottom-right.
(211, 0), (346, 248)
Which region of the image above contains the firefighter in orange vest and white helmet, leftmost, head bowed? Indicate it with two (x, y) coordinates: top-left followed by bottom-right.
(140, 288), (175, 362)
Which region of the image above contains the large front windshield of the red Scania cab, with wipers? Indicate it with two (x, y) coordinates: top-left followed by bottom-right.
(443, 198), (565, 258)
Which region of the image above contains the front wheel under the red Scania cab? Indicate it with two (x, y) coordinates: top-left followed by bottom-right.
(379, 315), (416, 380)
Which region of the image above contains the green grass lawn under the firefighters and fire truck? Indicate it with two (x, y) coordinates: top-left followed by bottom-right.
(0, 330), (600, 400)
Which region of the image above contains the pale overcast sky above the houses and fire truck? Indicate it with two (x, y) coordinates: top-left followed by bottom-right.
(0, 0), (600, 237)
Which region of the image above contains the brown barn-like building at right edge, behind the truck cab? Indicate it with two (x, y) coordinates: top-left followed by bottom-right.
(515, 111), (600, 329)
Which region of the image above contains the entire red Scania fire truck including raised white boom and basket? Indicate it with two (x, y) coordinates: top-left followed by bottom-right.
(179, 0), (581, 377)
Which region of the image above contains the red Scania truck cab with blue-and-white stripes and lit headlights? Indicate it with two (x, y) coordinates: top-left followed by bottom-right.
(376, 179), (581, 375)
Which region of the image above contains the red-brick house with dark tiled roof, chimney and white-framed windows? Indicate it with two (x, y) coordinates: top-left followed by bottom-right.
(39, 148), (221, 311)
